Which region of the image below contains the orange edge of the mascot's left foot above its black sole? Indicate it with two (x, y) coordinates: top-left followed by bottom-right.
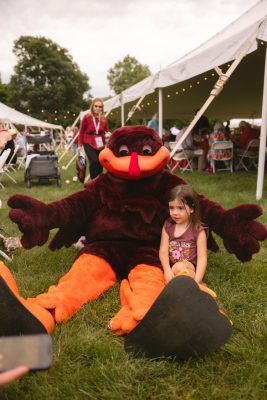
(0, 261), (55, 333)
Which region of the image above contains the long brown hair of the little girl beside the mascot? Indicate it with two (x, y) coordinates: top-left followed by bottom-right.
(169, 185), (201, 229)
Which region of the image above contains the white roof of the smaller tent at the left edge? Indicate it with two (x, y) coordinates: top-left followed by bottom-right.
(0, 102), (63, 130)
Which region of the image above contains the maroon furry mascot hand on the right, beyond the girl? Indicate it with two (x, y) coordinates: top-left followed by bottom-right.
(217, 204), (267, 262)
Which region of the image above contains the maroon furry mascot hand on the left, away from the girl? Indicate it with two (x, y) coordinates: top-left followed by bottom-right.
(8, 195), (52, 249)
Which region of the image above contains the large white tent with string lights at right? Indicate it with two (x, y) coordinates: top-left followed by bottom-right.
(105, 0), (267, 199)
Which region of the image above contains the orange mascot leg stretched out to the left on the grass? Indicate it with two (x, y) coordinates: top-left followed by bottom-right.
(31, 254), (116, 322)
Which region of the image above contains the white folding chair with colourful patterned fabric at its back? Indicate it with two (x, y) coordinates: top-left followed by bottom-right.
(210, 140), (233, 173)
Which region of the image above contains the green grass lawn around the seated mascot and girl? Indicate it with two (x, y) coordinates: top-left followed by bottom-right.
(0, 160), (267, 400)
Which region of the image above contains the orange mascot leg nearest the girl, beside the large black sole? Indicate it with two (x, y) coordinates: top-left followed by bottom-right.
(109, 264), (165, 335)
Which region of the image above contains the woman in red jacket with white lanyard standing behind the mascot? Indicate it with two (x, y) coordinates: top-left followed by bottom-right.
(78, 98), (108, 179)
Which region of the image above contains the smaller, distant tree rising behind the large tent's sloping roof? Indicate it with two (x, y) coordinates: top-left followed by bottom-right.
(107, 55), (151, 94)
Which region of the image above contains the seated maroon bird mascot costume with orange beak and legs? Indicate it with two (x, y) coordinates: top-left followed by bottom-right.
(0, 126), (267, 359)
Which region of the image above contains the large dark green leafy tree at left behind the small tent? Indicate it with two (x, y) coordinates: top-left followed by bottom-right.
(10, 36), (91, 126)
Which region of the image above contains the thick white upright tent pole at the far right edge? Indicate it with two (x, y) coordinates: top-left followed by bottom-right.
(256, 45), (267, 200)
